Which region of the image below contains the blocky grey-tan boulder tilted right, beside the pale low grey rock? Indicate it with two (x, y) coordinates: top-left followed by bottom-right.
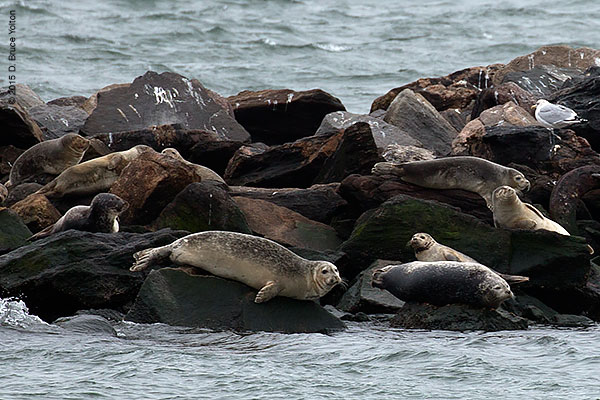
(383, 89), (458, 156)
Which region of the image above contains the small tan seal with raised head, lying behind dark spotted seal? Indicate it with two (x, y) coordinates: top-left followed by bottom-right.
(408, 232), (529, 285)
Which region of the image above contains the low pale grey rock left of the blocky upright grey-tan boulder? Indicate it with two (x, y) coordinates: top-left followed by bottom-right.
(315, 111), (422, 153)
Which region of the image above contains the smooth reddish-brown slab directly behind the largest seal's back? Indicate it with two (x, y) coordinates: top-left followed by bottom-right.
(234, 197), (342, 250)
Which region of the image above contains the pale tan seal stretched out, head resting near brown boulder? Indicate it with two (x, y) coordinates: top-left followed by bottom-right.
(36, 144), (154, 198)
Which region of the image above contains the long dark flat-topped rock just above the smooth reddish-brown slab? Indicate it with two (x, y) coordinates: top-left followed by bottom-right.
(230, 183), (347, 224)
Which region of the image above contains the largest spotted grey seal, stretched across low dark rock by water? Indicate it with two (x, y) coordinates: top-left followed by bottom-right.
(130, 231), (342, 303)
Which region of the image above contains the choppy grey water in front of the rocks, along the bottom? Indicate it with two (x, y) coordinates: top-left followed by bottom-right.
(0, 300), (600, 400)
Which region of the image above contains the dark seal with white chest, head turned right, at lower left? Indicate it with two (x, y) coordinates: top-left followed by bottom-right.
(29, 193), (129, 240)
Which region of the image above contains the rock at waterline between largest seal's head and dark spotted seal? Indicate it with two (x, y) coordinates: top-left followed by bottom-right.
(337, 260), (404, 314)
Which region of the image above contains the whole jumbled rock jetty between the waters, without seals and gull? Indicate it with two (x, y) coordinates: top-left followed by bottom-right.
(0, 46), (600, 332)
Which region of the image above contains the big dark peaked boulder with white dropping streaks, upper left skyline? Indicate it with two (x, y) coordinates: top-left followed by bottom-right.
(81, 71), (250, 142)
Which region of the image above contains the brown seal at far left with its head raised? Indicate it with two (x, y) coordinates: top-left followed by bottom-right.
(8, 133), (90, 186)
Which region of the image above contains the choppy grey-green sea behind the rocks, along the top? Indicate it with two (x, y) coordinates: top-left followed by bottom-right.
(0, 0), (600, 113)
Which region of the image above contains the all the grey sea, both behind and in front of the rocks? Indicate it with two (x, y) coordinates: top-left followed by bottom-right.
(0, 0), (600, 399)
